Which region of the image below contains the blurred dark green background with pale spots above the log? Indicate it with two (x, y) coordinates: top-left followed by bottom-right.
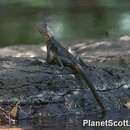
(0, 0), (130, 46)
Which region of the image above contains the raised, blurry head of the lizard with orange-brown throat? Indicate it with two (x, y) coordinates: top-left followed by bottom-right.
(37, 22), (51, 41)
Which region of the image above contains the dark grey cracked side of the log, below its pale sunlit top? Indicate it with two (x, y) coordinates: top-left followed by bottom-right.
(0, 57), (130, 116)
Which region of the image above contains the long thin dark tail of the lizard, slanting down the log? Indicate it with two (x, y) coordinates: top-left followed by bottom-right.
(76, 64), (106, 113)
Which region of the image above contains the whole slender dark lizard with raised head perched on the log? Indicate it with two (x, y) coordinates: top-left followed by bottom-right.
(37, 22), (106, 113)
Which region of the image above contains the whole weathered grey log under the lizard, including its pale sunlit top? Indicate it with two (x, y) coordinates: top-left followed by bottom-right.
(0, 38), (130, 116)
